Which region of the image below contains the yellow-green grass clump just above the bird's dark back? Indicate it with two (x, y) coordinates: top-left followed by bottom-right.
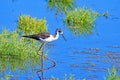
(17, 15), (47, 35)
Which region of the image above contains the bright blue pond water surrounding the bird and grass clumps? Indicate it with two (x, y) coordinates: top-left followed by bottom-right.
(0, 0), (120, 80)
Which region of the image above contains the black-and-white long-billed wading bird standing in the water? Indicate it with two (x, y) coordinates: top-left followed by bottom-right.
(23, 28), (66, 51)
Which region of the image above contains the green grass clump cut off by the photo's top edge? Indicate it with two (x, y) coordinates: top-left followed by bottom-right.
(48, 0), (75, 13)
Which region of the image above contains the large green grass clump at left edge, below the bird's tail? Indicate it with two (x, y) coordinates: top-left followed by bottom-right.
(0, 29), (40, 72)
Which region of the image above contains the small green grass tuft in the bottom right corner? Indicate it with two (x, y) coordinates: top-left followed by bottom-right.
(105, 67), (120, 80)
